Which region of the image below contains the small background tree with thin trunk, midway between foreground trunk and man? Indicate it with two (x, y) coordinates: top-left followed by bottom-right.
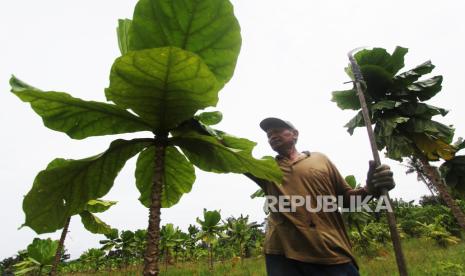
(197, 209), (227, 271)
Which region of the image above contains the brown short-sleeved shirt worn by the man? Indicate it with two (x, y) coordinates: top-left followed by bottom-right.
(257, 152), (366, 265)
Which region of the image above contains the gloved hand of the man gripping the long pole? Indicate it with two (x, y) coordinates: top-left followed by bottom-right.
(366, 160), (396, 197)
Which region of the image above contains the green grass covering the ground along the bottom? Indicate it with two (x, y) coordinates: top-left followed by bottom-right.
(69, 239), (465, 276)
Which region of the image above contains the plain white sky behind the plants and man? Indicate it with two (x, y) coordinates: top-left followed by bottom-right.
(0, 0), (465, 259)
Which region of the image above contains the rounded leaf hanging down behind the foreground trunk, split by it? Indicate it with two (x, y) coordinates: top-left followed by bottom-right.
(136, 146), (195, 208)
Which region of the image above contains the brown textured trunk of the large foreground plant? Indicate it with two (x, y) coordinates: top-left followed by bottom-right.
(144, 134), (168, 276)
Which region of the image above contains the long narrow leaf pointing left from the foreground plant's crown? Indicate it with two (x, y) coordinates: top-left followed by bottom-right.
(10, 76), (152, 139)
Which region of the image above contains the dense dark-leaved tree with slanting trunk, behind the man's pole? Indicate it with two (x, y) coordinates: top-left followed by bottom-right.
(332, 47), (465, 229)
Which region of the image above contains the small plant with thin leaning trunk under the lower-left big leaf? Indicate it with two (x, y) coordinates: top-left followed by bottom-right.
(50, 199), (116, 276)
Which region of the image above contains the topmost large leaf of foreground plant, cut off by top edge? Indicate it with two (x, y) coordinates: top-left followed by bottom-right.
(130, 0), (241, 83)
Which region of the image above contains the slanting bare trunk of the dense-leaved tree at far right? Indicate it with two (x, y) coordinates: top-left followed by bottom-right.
(417, 149), (465, 231)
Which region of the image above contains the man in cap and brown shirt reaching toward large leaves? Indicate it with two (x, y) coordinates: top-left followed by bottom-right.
(246, 118), (395, 276)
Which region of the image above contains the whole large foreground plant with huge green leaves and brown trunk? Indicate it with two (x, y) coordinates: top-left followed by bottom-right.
(10, 0), (282, 275)
